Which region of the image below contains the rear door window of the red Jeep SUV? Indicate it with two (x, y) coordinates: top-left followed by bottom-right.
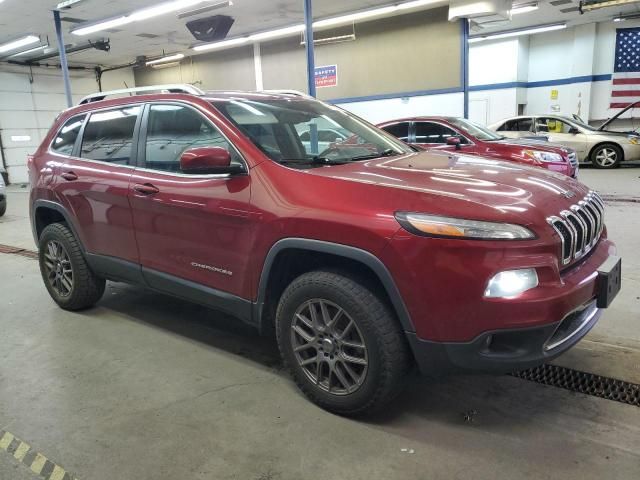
(80, 106), (142, 165)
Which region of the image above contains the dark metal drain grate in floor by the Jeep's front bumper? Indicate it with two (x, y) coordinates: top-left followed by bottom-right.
(511, 364), (640, 407)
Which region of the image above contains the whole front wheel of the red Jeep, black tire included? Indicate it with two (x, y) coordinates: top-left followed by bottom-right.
(276, 271), (412, 415)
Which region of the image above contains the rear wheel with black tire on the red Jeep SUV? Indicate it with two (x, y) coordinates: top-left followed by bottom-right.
(38, 223), (106, 310)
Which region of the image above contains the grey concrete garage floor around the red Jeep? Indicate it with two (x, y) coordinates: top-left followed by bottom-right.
(0, 168), (640, 480)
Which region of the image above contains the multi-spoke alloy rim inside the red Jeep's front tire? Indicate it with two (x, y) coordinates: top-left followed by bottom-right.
(291, 299), (369, 395)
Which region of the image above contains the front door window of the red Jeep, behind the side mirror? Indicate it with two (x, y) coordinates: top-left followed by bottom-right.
(145, 105), (242, 172)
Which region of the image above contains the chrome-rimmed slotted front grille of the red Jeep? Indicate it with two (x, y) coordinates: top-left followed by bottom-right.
(547, 191), (604, 265)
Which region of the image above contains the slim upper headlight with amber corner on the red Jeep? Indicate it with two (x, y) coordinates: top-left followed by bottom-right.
(396, 212), (535, 240)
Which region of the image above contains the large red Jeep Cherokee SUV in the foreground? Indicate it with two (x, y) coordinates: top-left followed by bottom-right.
(29, 87), (620, 414)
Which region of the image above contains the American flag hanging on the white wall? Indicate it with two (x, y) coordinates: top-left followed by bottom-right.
(609, 28), (640, 108)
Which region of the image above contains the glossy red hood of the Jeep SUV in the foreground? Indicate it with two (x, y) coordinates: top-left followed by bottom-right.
(308, 151), (589, 224)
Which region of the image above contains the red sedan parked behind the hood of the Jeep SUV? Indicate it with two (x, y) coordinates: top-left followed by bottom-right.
(378, 117), (578, 178)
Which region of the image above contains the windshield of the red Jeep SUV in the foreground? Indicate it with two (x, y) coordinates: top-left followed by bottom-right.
(212, 97), (413, 168)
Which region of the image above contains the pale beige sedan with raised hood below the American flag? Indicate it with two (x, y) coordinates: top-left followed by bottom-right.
(489, 112), (640, 168)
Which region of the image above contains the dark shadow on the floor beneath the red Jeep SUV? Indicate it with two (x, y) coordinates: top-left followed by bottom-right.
(99, 282), (616, 431)
